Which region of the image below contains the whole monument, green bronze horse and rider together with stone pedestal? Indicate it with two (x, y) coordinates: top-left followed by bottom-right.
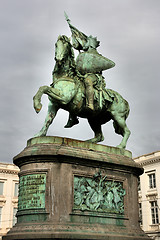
(3, 14), (149, 240)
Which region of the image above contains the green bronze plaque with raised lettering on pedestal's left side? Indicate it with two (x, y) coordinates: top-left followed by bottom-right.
(18, 173), (46, 210)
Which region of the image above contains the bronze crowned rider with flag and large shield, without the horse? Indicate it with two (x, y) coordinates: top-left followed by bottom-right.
(65, 11), (115, 127)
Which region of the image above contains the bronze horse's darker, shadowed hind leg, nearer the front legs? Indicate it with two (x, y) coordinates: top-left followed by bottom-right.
(86, 119), (104, 143)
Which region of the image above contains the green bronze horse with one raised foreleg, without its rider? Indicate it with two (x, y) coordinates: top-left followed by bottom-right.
(33, 35), (130, 149)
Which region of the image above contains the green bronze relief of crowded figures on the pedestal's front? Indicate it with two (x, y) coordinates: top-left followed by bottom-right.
(73, 172), (126, 214)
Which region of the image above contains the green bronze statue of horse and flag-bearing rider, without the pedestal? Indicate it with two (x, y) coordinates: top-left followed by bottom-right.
(33, 13), (130, 148)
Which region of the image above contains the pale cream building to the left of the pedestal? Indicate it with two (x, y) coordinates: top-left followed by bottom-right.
(0, 163), (19, 239)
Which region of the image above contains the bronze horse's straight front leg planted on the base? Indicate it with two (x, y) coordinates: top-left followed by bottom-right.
(34, 101), (59, 137)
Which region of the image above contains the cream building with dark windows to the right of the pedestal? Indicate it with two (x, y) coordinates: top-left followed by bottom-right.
(134, 151), (160, 240)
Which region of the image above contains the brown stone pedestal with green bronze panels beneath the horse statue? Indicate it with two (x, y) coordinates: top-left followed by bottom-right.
(3, 137), (149, 240)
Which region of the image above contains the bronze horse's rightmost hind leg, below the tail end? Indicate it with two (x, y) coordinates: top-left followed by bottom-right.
(113, 116), (131, 148)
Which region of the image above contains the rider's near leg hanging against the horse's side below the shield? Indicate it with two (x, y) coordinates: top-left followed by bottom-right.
(85, 78), (94, 111)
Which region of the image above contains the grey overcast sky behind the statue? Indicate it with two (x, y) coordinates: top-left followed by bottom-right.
(0, 0), (160, 162)
